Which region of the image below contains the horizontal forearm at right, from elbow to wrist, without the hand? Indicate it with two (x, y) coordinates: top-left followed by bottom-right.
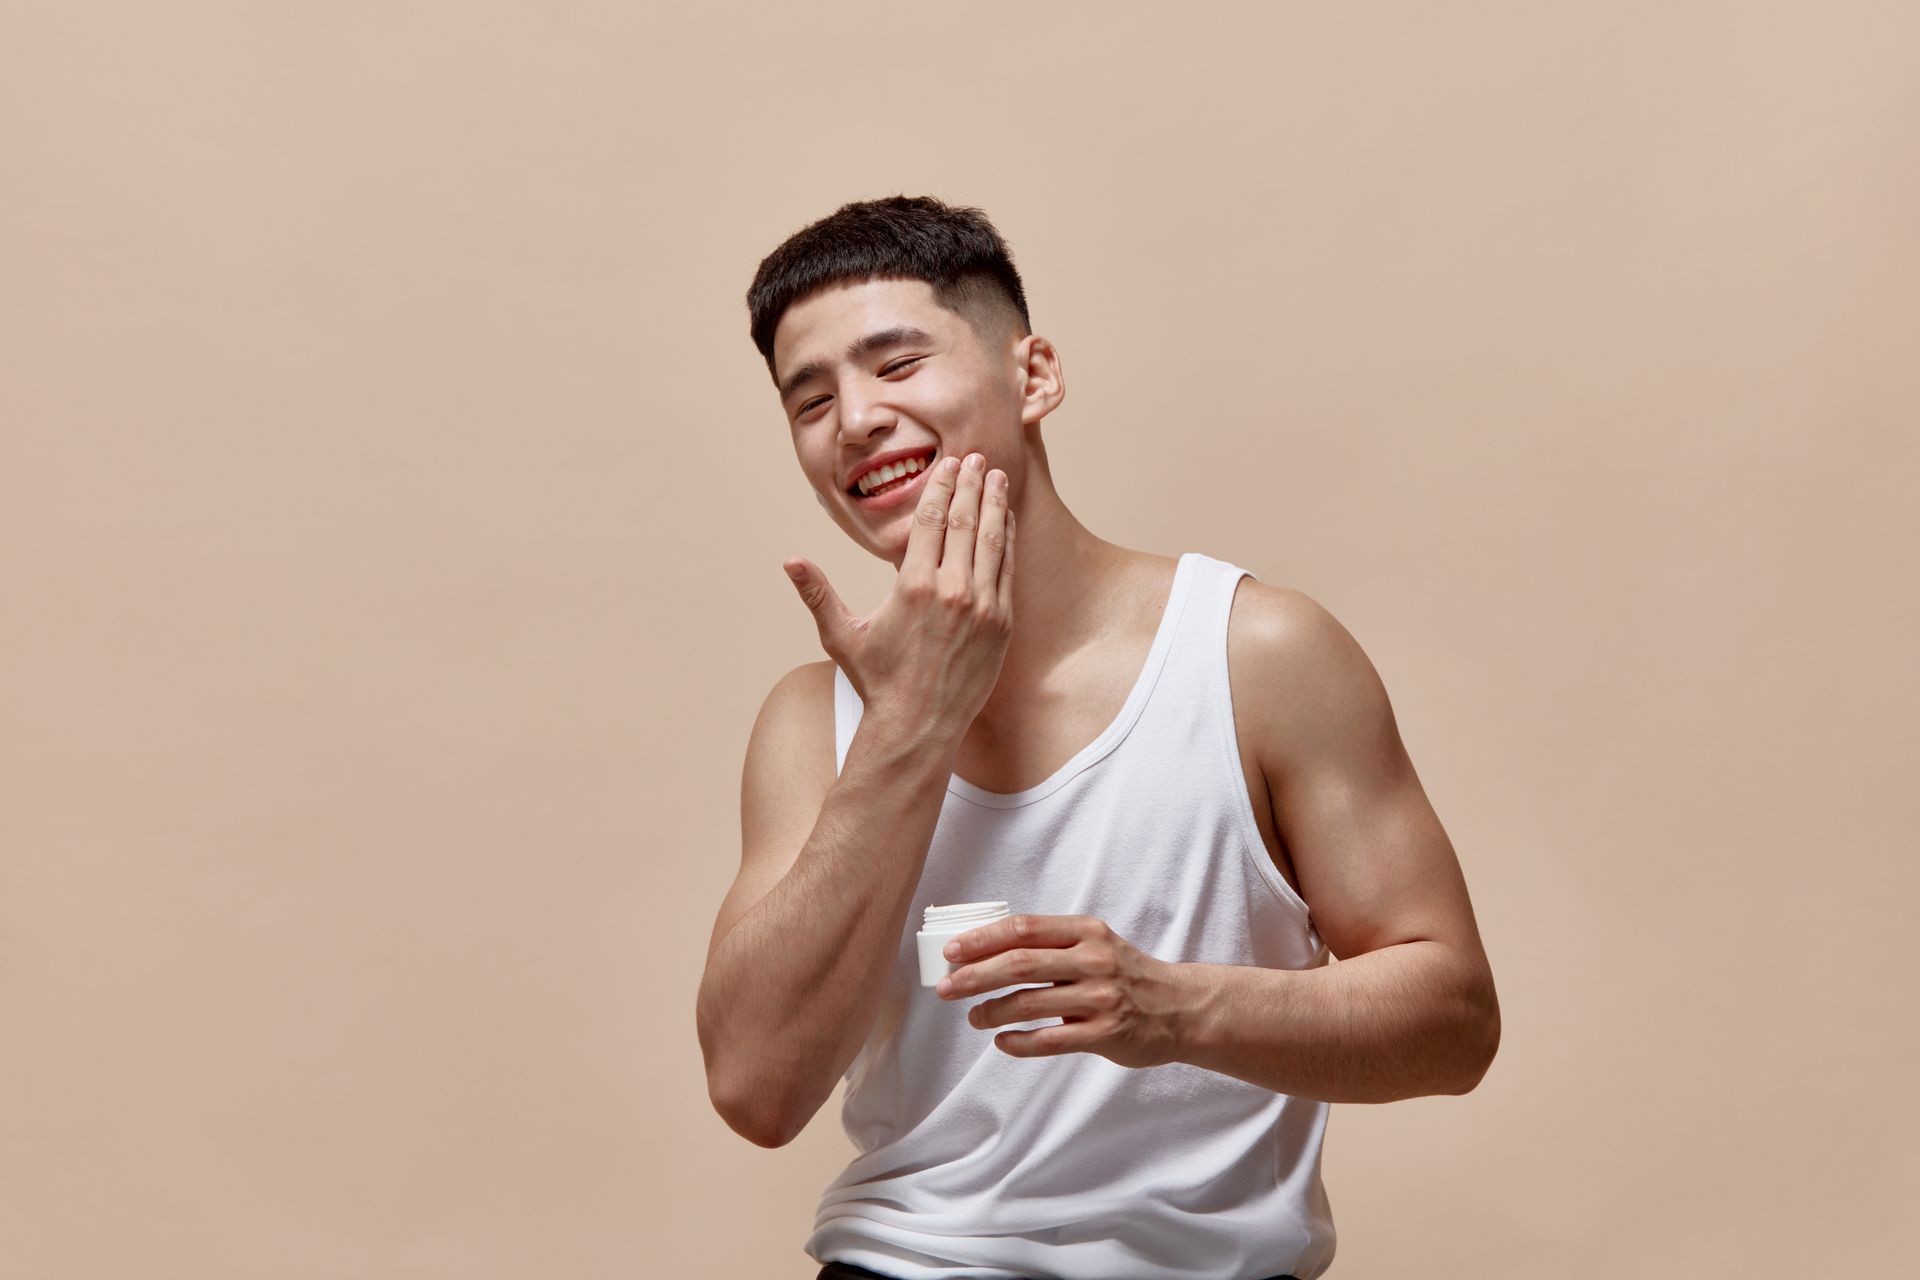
(1173, 940), (1500, 1102)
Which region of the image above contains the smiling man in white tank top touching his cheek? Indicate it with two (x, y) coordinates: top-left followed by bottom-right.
(697, 196), (1500, 1280)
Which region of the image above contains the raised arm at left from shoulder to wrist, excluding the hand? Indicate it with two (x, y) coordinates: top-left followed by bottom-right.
(697, 662), (958, 1146)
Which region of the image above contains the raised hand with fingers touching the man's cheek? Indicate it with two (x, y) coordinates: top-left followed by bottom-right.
(785, 453), (1014, 733)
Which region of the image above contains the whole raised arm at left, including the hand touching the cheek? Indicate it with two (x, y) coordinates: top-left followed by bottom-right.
(697, 455), (1014, 1146)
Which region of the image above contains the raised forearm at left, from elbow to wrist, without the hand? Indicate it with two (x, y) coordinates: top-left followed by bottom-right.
(697, 712), (956, 1146)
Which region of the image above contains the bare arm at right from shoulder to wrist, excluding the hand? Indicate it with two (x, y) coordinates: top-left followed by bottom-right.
(1175, 583), (1500, 1102)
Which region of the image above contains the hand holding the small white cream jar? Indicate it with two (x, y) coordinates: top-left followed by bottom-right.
(935, 915), (1187, 1067)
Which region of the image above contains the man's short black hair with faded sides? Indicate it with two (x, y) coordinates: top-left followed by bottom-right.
(747, 196), (1033, 378)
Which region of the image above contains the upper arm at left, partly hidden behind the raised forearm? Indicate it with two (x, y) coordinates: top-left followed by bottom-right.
(707, 662), (833, 958)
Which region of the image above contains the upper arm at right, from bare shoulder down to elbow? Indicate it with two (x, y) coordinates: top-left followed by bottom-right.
(1269, 593), (1484, 963)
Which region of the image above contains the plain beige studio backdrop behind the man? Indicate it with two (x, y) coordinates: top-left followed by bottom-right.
(0, 2), (1920, 1280)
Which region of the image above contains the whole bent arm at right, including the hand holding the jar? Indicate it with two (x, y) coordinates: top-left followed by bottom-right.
(939, 581), (1500, 1102)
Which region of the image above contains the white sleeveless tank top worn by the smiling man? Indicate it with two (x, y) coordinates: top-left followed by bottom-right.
(804, 553), (1334, 1280)
